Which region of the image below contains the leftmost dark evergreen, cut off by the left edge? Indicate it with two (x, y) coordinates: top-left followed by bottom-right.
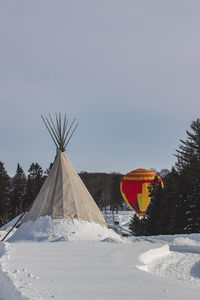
(0, 161), (10, 226)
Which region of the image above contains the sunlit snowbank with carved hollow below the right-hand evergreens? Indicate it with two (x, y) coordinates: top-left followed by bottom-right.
(137, 234), (200, 285)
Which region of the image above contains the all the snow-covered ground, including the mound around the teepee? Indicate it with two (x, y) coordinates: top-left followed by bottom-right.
(0, 212), (200, 300)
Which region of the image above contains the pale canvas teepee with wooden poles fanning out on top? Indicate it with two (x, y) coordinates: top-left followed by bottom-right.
(23, 114), (107, 226)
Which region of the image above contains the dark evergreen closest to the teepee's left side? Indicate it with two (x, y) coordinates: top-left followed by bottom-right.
(24, 163), (44, 210)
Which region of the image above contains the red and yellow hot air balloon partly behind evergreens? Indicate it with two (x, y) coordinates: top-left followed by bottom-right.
(120, 169), (163, 216)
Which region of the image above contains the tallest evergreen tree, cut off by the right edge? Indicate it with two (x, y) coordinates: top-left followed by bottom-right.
(175, 119), (200, 233)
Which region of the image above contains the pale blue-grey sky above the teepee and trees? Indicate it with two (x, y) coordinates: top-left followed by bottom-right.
(0, 0), (200, 175)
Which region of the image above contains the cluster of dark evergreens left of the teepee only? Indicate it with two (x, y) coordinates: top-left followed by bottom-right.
(0, 162), (45, 226)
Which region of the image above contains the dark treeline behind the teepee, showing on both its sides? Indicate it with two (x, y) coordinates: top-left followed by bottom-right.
(0, 162), (124, 227)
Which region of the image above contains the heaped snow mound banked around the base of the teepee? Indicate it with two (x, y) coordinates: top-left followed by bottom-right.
(7, 216), (124, 243)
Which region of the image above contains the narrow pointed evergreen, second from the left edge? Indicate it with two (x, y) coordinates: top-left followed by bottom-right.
(12, 163), (26, 217)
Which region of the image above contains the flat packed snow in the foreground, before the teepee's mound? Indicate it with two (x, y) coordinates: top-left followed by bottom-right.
(1, 240), (200, 300)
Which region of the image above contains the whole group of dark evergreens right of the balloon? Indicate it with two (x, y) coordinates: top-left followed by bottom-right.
(130, 119), (200, 235)
